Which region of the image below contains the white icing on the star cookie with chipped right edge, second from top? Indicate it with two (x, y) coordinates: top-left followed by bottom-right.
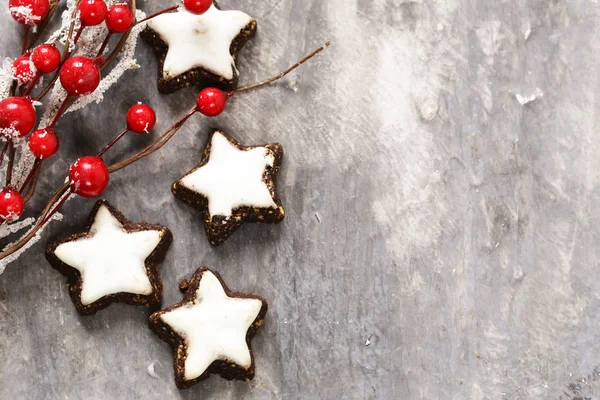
(181, 132), (277, 218)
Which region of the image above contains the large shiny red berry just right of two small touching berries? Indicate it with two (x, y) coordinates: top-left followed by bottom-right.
(60, 56), (100, 96)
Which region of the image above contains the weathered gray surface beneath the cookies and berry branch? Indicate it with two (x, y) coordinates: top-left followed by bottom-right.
(0, 0), (600, 400)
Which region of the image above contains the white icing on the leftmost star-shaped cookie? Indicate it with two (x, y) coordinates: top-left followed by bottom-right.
(54, 206), (162, 305)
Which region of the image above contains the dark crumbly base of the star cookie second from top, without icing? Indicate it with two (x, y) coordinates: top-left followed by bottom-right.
(171, 130), (285, 246)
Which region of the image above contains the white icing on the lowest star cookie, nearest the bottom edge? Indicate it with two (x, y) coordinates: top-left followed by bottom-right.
(161, 271), (262, 381)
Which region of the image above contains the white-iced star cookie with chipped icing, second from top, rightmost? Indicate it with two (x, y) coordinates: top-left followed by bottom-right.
(172, 131), (285, 246)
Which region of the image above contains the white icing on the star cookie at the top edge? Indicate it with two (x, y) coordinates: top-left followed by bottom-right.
(148, 4), (252, 80)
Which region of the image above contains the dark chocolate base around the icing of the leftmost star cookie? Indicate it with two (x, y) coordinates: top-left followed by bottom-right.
(46, 200), (173, 315)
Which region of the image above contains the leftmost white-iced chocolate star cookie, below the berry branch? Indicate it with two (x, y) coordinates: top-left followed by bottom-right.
(46, 200), (173, 315)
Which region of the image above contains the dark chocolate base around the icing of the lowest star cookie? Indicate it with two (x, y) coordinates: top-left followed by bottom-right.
(148, 268), (268, 389)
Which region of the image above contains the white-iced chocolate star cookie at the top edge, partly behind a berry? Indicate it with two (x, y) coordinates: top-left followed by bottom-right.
(142, 2), (256, 93)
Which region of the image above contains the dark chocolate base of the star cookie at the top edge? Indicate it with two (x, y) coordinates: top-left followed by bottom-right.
(140, 1), (257, 94)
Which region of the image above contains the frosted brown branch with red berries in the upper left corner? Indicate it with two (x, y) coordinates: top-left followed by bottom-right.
(0, 0), (329, 273)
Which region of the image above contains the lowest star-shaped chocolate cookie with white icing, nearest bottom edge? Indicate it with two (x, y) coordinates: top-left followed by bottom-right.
(148, 268), (268, 389)
